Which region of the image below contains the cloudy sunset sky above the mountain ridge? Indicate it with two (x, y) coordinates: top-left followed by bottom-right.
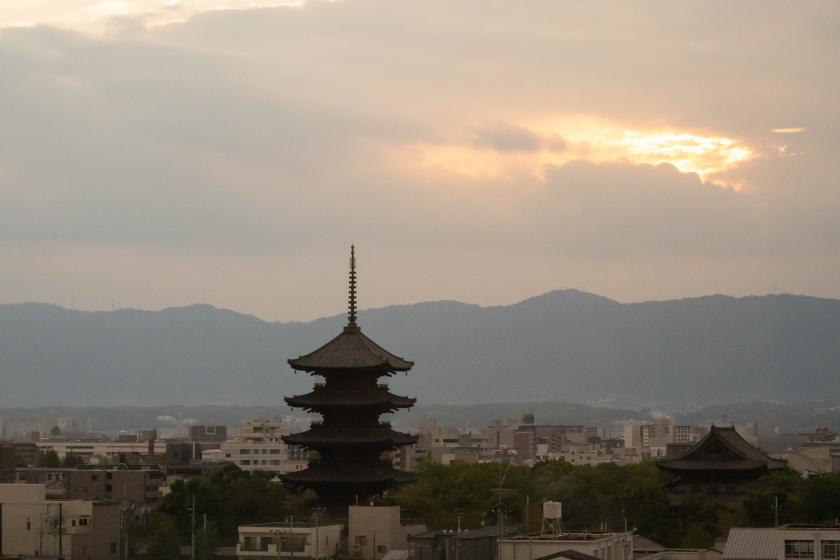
(0, 0), (840, 320)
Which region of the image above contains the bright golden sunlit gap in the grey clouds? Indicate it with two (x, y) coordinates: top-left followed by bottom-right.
(396, 117), (756, 187)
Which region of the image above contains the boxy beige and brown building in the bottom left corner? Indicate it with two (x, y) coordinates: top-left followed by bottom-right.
(0, 484), (120, 560)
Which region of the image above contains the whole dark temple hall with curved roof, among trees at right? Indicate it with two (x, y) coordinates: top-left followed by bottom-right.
(656, 426), (787, 494)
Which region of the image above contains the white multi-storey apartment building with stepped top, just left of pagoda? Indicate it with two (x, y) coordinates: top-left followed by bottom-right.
(221, 418), (306, 473)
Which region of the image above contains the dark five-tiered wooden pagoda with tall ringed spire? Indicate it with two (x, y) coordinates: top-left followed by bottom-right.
(281, 247), (417, 509)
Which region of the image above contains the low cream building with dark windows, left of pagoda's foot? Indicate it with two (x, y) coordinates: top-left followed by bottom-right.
(236, 522), (344, 560)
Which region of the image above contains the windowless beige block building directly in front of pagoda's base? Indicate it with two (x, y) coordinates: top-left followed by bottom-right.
(347, 506), (426, 560)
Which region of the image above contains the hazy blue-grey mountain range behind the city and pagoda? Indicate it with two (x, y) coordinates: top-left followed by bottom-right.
(0, 290), (840, 407)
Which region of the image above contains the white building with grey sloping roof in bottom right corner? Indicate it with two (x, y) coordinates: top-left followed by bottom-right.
(723, 525), (840, 560)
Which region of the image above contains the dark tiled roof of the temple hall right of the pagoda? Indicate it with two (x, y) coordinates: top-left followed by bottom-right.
(657, 426), (787, 472)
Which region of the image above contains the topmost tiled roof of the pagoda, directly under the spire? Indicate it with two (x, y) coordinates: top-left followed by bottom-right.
(289, 323), (414, 372)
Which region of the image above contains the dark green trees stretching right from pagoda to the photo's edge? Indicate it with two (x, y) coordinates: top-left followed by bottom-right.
(391, 461), (840, 547)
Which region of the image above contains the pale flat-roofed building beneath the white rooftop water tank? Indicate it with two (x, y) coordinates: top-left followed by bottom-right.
(499, 532), (633, 560)
